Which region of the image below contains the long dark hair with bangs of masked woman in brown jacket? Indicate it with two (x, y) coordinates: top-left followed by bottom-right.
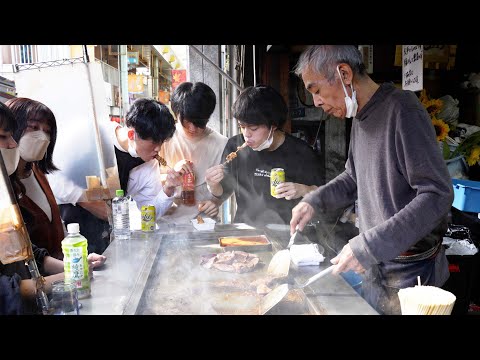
(5, 98), (58, 174)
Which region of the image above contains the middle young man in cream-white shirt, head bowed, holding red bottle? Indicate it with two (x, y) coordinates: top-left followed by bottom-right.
(160, 82), (227, 223)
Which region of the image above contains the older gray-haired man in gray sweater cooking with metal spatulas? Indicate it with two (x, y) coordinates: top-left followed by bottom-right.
(290, 45), (453, 314)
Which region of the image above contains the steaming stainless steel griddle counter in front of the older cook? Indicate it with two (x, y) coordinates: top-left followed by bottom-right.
(80, 224), (377, 315)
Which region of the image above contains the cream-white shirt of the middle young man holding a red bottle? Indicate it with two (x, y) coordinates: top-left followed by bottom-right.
(160, 121), (228, 224)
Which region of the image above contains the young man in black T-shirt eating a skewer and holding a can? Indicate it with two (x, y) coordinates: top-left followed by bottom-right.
(206, 85), (322, 226)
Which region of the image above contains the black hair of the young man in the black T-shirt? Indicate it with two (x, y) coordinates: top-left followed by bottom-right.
(232, 85), (288, 129)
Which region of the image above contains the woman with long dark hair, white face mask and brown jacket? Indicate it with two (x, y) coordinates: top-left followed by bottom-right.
(5, 98), (65, 259)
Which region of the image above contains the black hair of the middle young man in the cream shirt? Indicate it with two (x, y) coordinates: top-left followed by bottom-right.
(170, 81), (217, 129)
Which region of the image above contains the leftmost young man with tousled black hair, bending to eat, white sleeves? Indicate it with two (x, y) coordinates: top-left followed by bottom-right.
(113, 98), (182, 220)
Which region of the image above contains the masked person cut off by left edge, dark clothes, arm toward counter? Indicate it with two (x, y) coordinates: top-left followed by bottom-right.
(0, 103), (106, 315)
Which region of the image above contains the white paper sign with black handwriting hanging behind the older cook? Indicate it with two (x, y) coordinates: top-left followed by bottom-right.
(402, 45), (423, 91)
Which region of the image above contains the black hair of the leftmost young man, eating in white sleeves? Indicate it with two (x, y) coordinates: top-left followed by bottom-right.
(125, 98), (175, 143)
